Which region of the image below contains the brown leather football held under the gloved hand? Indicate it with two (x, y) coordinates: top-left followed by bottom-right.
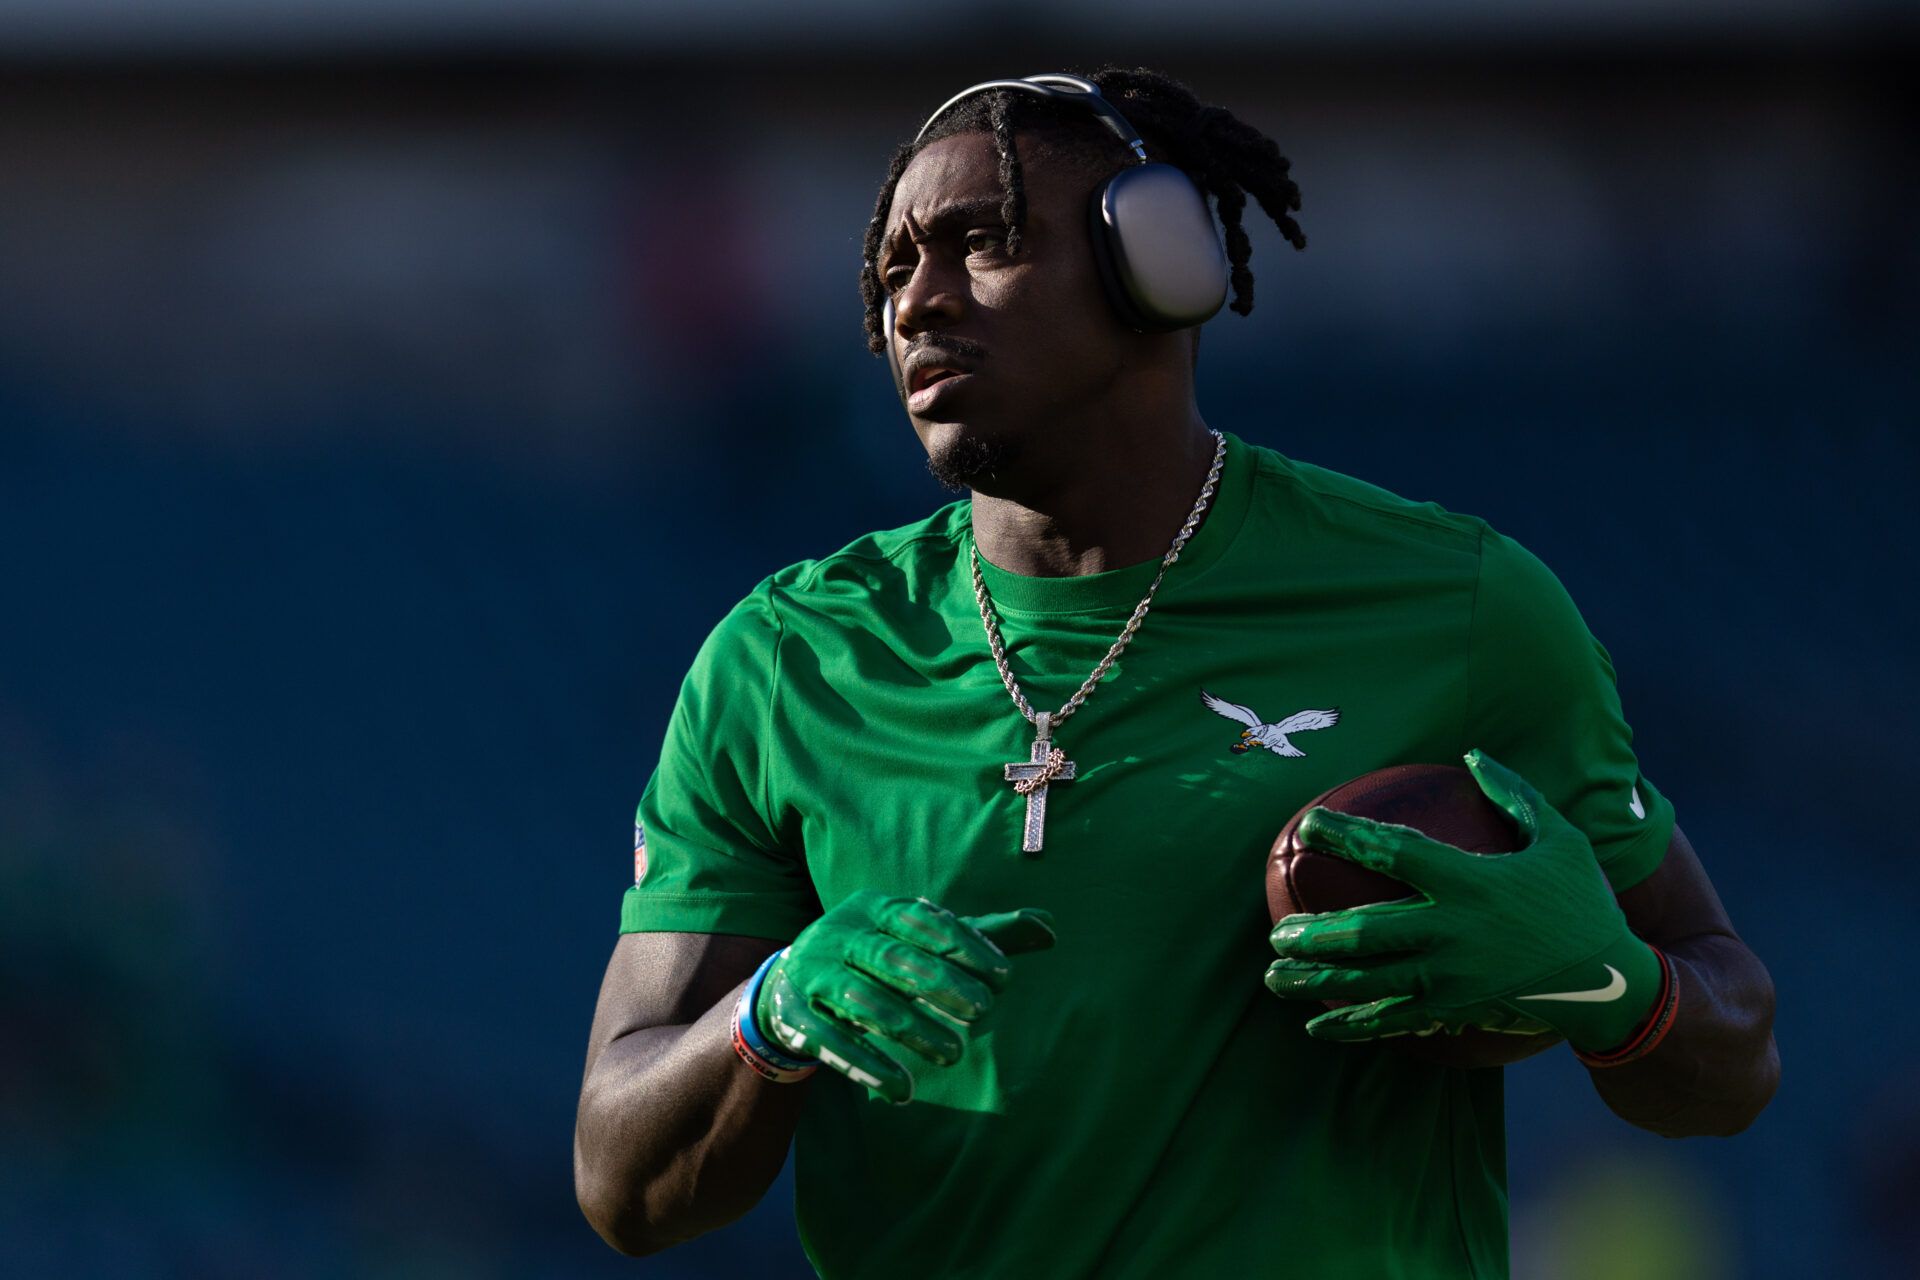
(1267, 764), (1561, 1067)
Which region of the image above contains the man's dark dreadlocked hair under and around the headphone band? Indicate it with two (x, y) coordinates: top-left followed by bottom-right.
(860, 65), (1308, 355)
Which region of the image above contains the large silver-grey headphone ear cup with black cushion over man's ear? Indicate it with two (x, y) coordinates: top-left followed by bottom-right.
(1087, 163), (1227, 334)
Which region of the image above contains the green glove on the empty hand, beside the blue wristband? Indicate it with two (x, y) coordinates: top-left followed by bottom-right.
(755, 889), (1054, 1103)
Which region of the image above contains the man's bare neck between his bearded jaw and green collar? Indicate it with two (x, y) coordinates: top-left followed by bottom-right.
(973, 411), (1213, 578)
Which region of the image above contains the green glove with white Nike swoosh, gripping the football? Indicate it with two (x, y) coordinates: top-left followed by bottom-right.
(1267, 750), (1663, 1054)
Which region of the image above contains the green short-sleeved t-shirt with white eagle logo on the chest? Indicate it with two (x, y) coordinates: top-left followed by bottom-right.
(622, 436), (1672, 1280)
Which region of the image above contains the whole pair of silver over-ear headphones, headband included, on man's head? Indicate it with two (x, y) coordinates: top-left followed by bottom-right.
(881, 71), (1227, 386)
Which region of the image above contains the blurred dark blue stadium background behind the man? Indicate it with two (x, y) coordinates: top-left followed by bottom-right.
(0, 0), (1920, 1280)
